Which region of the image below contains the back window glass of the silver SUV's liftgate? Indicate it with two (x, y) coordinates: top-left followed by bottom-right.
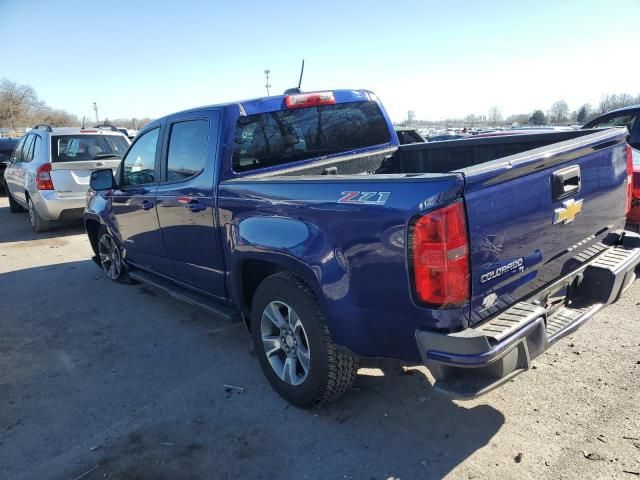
(51, 135), (129, 162)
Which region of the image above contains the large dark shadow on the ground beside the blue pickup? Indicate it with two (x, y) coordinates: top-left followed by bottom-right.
(0, 258), (505, 480)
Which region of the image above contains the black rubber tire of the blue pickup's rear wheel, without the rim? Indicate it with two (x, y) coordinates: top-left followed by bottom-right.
(251, 272), (359, 408)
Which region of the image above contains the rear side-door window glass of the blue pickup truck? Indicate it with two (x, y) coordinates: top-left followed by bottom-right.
(167, 120), (209, 182)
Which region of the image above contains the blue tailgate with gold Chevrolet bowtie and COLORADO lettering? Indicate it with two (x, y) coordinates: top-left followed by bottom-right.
(461, 129), (627, 324)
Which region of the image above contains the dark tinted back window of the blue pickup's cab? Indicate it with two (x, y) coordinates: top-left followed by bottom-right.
(233, 102), (390, 172)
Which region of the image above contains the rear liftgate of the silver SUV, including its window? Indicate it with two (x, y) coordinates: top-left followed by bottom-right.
(51, 133), (129, 197)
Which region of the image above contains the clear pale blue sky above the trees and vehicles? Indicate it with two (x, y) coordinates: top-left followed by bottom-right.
(0, 0), (640, 120)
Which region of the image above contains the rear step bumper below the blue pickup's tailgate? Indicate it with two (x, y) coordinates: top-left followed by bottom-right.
(416, 232), (640, 399)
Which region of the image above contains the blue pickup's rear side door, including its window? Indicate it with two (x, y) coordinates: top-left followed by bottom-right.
(156, 111), (226, 298)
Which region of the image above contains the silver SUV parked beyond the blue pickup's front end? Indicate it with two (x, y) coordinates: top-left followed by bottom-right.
(4, 124), (129, 232)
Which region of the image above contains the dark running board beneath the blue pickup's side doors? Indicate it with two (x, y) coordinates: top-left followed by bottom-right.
(129, 270), (242, 323)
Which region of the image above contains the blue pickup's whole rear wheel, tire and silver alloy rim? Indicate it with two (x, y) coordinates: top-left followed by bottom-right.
(251, 273), (358, 407)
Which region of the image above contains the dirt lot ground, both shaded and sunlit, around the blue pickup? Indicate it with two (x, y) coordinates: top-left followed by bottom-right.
(0, 197), (640, 480)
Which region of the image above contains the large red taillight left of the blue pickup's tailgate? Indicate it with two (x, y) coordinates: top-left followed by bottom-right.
(410, 202), (469, 307)
